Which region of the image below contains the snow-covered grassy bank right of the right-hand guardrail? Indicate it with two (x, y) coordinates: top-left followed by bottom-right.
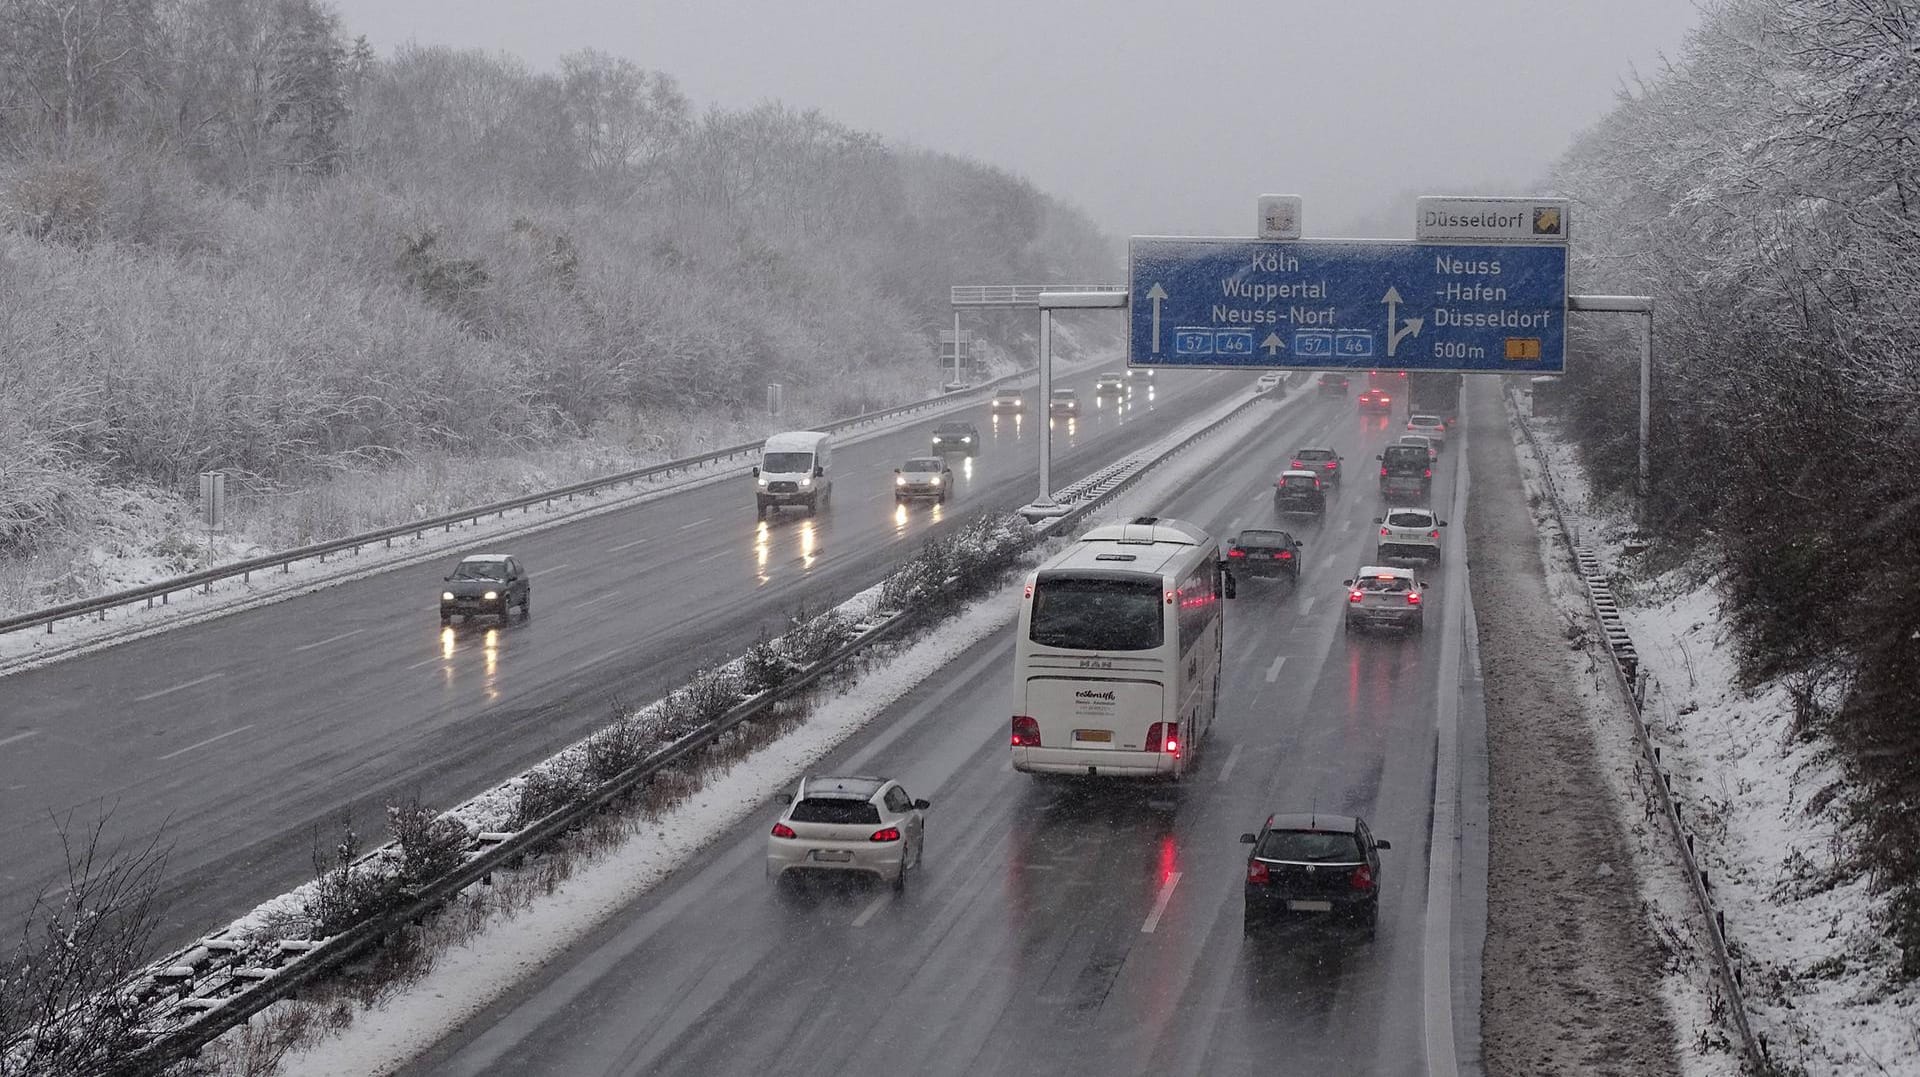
(1523, 395), (1920, 1077)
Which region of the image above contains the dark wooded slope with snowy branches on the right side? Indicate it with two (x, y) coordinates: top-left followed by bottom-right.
(1557, 0), (1920, 977)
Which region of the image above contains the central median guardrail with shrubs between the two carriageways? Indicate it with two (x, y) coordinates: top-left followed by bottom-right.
(63, 374), (1308, 1077)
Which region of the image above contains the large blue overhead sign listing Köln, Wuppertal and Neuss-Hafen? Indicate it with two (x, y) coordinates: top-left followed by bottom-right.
(1127, 236), (1567, 374)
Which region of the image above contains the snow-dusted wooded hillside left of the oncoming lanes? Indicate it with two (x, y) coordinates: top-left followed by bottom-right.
(0, 0), (1117, 595)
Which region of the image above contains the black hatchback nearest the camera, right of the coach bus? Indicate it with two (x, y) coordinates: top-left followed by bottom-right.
(1240, 812), (1392, 939)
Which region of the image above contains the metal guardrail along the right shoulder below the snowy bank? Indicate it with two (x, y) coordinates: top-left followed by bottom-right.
(1505, 383), (1770, 1071)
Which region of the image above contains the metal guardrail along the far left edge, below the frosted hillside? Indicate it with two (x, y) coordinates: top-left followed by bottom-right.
(0, 367), (1082, 635)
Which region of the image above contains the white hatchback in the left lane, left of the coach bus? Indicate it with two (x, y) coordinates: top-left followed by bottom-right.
(766, 776), (931, 891)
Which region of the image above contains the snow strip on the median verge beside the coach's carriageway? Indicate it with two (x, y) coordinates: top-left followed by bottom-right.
(247, 372), (1273, 1077)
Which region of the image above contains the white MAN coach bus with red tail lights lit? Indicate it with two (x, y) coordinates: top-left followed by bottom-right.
(1014, 516), (1233, 779)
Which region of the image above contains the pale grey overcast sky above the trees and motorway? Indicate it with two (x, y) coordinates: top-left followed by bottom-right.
(334, 0), (1697, 236)
